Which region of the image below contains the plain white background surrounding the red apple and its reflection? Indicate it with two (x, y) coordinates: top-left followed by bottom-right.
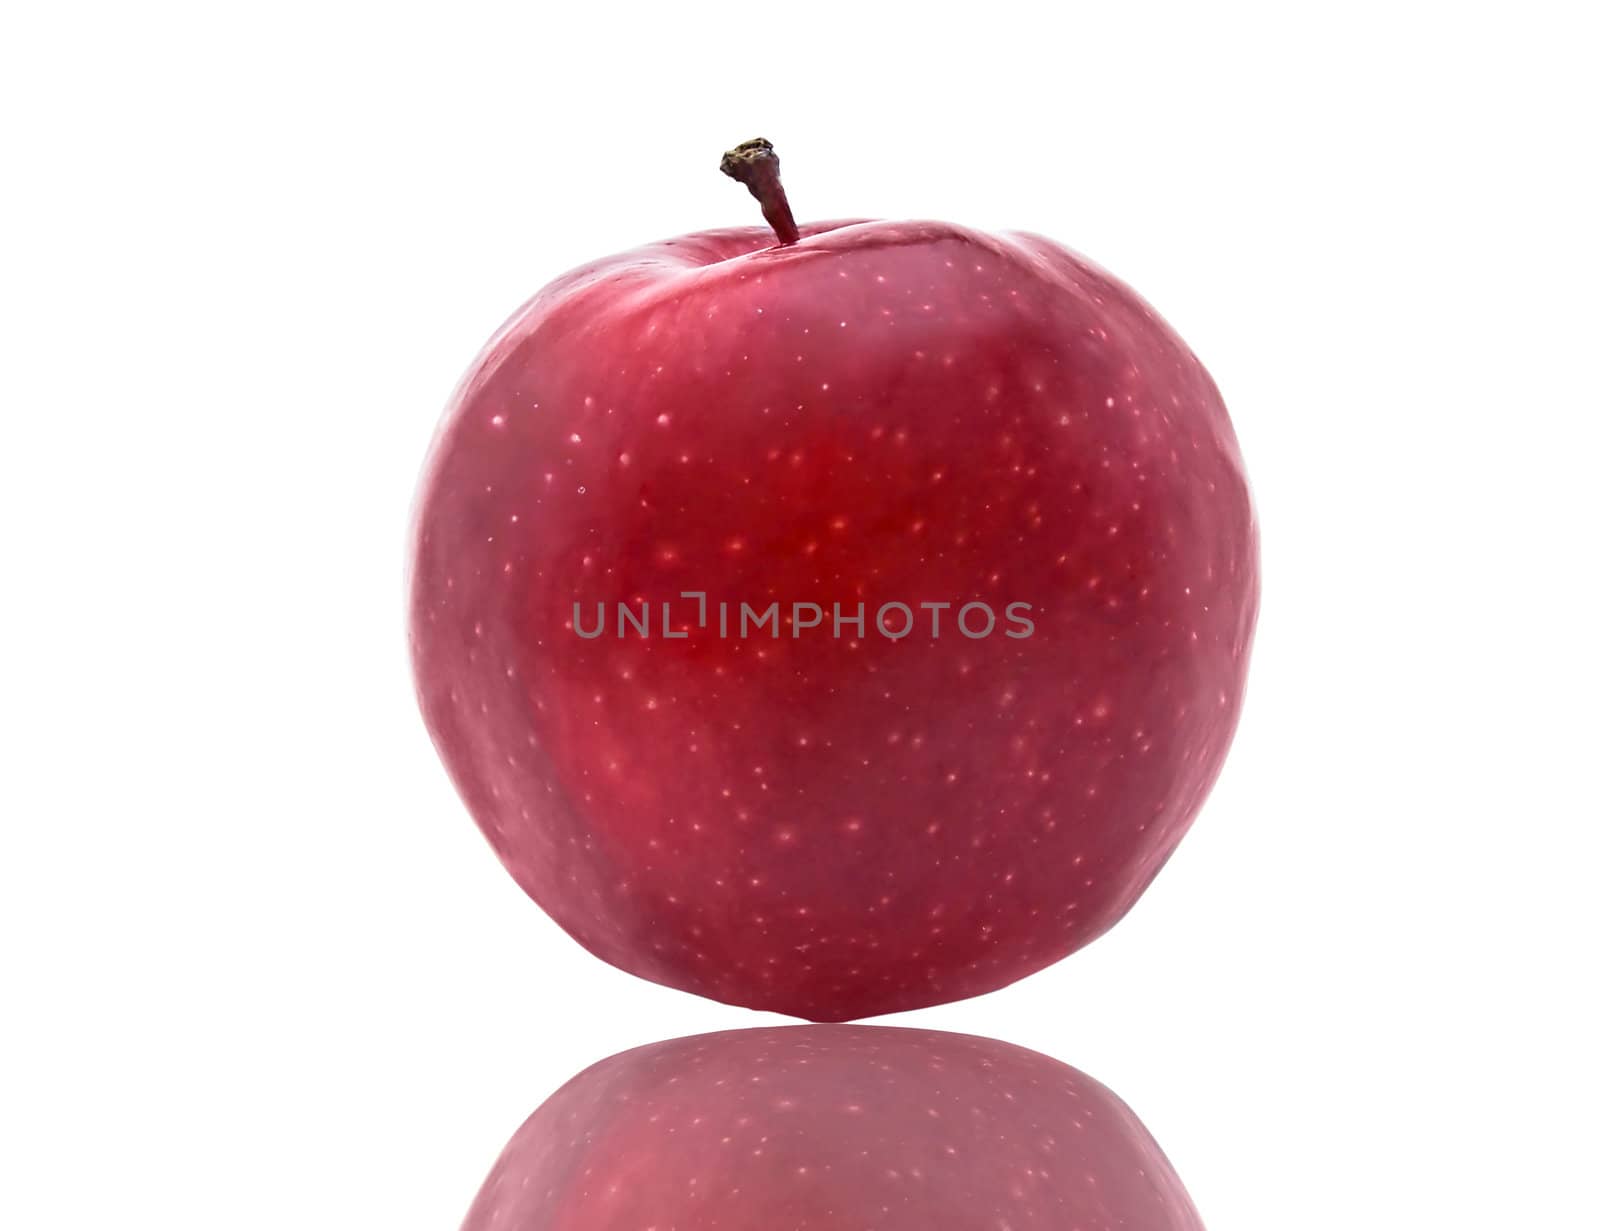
(0, 0), (1600, 1231)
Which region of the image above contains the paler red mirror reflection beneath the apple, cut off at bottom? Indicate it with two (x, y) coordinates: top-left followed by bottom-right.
(462, 1026), (1202, 1231)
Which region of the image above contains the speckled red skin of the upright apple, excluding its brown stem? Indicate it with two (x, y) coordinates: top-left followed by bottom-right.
(410, 223), (1258, 1021)
